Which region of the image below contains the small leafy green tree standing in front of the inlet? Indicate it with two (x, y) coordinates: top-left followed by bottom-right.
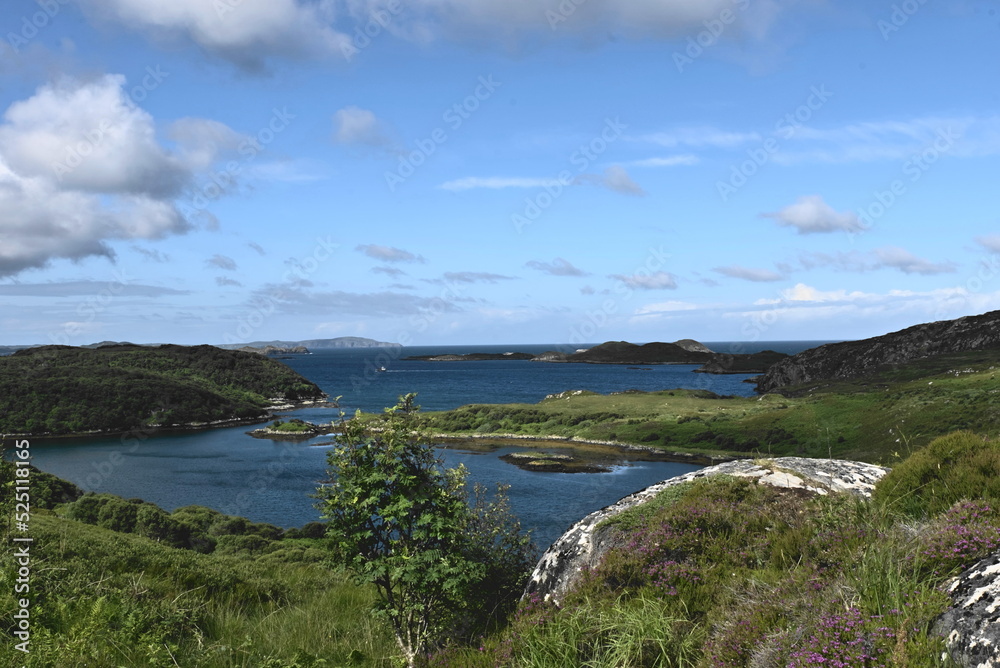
(316, 394), (531, 667)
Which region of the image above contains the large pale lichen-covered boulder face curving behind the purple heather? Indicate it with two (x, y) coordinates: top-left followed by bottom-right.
(525, 457), (889, 601)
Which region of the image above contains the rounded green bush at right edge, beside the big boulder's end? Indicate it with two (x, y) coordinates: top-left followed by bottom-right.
(872, 431), (1000, 517)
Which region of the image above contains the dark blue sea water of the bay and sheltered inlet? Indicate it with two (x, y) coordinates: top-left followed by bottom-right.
(17, 342), (817, 547)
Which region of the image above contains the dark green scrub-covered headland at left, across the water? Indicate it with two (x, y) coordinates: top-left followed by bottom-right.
(0, 344), (327, 436)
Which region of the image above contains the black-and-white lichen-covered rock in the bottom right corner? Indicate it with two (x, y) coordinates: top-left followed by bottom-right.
(935, 553), (1000, 668)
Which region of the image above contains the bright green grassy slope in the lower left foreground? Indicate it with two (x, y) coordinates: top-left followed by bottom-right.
(0, 511), (395, 668)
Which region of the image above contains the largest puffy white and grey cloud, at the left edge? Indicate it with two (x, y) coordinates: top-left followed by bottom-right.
(0, 74), (249, 276)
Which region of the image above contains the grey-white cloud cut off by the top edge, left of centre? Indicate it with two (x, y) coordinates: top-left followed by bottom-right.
(74, 0), (353, 71)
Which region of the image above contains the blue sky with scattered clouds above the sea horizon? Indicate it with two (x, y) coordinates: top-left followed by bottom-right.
(0, 0), (1000, 345)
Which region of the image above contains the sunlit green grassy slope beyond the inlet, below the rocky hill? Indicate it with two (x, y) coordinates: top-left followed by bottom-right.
(427, 351), (1000, 462)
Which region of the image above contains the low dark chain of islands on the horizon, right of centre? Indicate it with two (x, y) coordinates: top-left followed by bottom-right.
(404, 339), (788, 374)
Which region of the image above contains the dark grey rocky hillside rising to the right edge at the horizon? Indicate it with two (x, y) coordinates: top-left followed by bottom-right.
(757, 311), (1000, 393)
